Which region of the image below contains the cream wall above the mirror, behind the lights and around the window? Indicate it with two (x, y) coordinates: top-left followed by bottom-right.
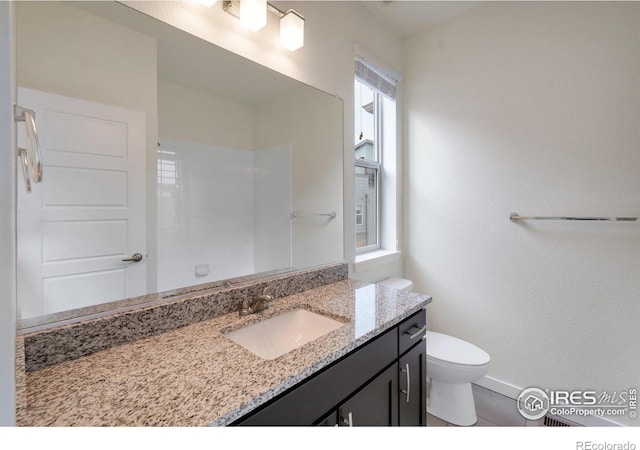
(124, 1), (402, 280)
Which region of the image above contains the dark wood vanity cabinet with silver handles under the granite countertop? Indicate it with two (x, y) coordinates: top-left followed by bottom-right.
(232, 309), (426, 426)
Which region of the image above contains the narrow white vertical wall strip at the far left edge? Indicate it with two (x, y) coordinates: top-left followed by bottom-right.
(0, 2), (17, 426)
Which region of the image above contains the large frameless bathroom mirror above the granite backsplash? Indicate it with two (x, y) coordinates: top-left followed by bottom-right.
(16, 1), (343, 328)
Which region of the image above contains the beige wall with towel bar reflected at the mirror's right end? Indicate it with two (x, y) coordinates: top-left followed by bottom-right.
(254, 85), (344, 268)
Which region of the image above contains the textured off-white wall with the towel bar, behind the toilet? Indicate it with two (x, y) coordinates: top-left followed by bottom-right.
(404, 2), (640, 425)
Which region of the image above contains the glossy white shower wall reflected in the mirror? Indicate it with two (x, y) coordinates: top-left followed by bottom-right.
(158, 138), (291, 291)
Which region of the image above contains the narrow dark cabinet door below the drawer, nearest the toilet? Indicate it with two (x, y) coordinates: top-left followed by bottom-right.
(398, 341), (427, 426)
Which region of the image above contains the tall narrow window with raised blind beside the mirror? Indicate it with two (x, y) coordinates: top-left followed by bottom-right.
(354, 53), (397, 253)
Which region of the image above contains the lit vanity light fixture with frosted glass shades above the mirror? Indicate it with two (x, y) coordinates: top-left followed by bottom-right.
(224, 0), (304, 51)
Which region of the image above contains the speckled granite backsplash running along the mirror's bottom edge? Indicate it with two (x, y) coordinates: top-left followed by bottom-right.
(23, 263), (348, 371)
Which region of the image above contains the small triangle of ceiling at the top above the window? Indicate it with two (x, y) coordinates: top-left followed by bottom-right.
(360, 0), (484, 38)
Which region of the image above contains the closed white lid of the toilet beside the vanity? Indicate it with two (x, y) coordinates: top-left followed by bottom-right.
(427, 331), (491, 366)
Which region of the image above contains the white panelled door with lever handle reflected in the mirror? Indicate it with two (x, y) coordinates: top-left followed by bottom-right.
(17, 88), (147, 319)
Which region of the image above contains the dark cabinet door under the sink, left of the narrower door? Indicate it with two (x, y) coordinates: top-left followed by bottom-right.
(338, 364), (398, 426)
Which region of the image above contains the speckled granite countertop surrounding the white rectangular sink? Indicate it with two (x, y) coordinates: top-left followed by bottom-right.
(18, 280), (431, 426)
